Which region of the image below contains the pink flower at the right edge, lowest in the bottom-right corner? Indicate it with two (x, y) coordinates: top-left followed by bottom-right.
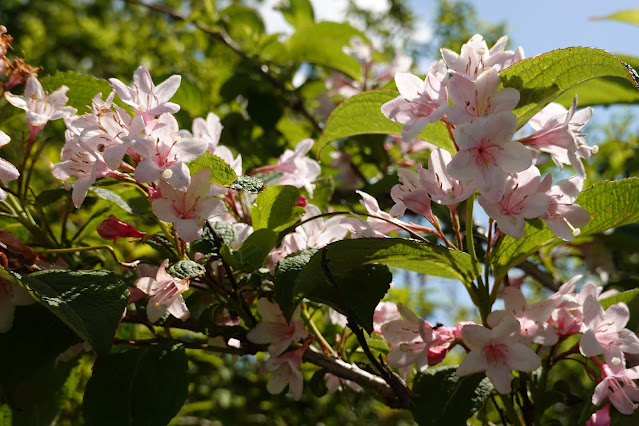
(592, 365), (639, 414)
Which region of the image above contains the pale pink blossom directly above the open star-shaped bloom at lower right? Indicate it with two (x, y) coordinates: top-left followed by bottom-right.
(486, 287), (558, 346)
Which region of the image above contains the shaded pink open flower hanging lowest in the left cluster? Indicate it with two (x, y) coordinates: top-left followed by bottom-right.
(151, 169), (226, 241)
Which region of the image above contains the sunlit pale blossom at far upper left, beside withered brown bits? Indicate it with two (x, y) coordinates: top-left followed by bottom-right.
(5, 76), (77, 128)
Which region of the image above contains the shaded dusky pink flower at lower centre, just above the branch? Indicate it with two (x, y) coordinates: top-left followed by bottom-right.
(246, 298), (308, 358)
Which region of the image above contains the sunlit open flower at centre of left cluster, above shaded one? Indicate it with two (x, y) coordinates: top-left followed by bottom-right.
(131, 113), (208, 190)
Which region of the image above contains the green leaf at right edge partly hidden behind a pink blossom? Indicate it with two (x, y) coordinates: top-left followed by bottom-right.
(490, 178), (639, 281)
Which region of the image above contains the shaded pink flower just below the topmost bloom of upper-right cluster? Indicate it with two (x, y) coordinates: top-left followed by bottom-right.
(446, 68), (519, 125)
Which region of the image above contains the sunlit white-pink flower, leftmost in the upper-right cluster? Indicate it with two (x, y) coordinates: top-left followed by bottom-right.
(382, 61), (448, 142)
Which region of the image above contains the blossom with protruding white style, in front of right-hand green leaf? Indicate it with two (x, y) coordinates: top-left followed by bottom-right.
(541, 175), (590, 241)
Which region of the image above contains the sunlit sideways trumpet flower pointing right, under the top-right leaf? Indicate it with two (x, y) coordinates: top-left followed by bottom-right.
(521, 95), (598, 177)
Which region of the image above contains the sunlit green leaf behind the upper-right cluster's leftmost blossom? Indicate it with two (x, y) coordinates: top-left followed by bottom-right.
(317, 90), (457, 153)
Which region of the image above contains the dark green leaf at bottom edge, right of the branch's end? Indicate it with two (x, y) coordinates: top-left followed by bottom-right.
(411, 367), (493, 426)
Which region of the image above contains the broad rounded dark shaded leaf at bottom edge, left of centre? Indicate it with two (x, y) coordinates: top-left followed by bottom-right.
(82, 345), (189, 426)
